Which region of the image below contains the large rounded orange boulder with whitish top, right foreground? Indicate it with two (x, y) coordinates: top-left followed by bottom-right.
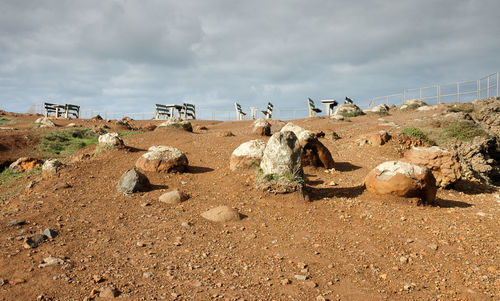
(365, 161), (437, 204)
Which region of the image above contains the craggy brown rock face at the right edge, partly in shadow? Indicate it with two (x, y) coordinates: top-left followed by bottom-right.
(454, 136), (500, 185)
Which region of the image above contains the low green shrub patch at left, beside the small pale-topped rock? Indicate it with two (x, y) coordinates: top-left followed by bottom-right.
(40, 129), (98, 155)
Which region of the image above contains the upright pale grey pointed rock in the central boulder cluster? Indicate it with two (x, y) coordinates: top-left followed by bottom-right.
(260, 131), (304, 177)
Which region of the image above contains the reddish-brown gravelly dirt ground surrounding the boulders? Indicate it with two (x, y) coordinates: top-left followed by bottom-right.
(0, 106), (500, 300)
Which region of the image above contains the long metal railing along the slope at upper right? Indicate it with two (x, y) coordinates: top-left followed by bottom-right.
(369, 72), (500, 108)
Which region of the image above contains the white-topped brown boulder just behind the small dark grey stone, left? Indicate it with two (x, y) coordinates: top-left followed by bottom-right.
(135, 145), (188, 172)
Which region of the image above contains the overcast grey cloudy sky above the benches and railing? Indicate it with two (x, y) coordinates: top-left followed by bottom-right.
(0, 0), (500, 117)
